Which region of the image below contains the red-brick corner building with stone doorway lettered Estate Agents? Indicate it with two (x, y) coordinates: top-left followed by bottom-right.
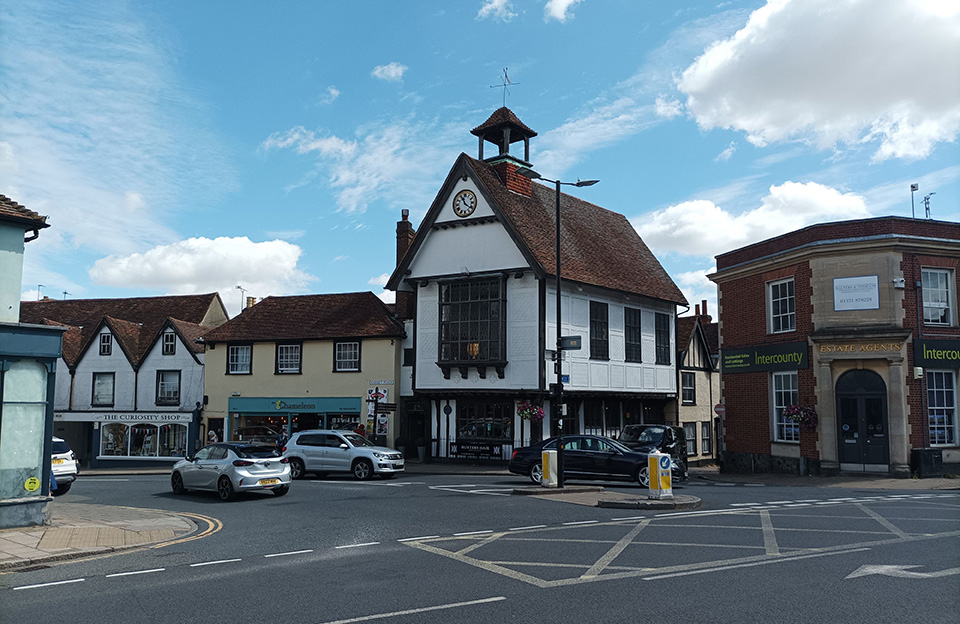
(710, 217), (960, 476)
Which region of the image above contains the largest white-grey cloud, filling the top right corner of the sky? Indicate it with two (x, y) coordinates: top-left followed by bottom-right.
(678, 0), (960, 160)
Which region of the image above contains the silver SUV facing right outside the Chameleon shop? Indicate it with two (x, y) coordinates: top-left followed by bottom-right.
(283, 429), (403, 480)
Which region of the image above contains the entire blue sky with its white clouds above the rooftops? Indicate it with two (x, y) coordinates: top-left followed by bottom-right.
(0, 0), (960, 314)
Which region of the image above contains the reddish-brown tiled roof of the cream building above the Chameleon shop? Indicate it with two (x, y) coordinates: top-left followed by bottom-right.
(203, 292), (403, 343)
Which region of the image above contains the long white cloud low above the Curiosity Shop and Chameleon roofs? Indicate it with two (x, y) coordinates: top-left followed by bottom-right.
(90, 236), (316, 316)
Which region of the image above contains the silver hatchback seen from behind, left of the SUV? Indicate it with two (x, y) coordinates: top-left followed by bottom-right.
(170, 442), (290, 501)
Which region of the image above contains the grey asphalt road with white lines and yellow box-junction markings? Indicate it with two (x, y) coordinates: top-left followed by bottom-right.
(0, 475), (960, 624)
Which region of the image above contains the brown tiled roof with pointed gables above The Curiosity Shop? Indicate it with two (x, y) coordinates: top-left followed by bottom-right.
(20, 293), (222, 367)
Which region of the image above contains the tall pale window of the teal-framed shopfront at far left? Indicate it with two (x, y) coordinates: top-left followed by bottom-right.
(0, 360), (50, 499)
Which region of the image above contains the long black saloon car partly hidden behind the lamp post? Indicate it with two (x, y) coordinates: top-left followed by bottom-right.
(509, 434), (680, 487)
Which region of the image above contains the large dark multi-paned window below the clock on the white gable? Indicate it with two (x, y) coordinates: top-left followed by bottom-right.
(439, 278), (507, 364)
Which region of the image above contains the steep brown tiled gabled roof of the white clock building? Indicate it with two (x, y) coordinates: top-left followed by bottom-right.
(387, 154), (687, 305)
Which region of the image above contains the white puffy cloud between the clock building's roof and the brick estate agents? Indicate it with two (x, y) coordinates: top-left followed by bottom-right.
(631, 182), (871, 258)
